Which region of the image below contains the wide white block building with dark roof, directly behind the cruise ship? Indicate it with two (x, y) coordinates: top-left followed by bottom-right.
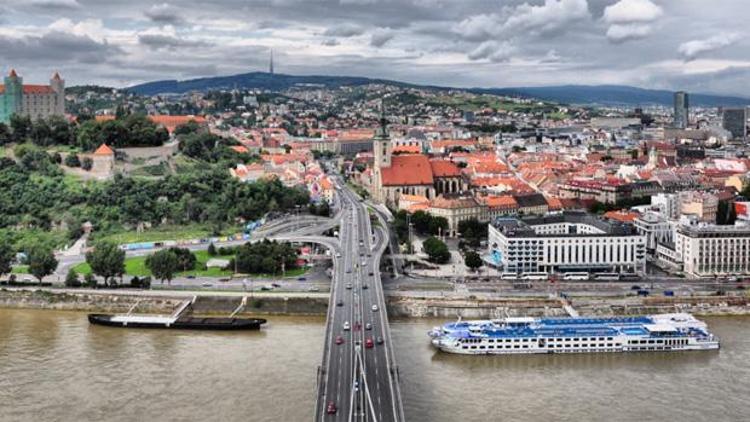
(488, 212), (646, 274)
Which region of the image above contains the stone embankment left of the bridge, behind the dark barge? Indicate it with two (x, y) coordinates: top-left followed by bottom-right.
(0, 289), (328, 316)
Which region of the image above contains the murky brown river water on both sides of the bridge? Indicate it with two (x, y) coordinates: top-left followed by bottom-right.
(0, 309), (750, 422)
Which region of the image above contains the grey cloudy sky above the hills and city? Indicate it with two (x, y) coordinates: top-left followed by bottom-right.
(0, 0), (750, 96)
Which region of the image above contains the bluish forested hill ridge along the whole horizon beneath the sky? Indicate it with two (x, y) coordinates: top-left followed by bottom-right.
(128, 72), (750, 107)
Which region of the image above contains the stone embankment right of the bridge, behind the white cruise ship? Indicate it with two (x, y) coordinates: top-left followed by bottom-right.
(388, 296), (750, 319)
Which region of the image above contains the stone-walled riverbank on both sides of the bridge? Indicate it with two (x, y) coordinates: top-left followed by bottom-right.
(0, 288), (750, 319)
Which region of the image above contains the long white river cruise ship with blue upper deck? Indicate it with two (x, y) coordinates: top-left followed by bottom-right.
(429, 313), (719, 355)
